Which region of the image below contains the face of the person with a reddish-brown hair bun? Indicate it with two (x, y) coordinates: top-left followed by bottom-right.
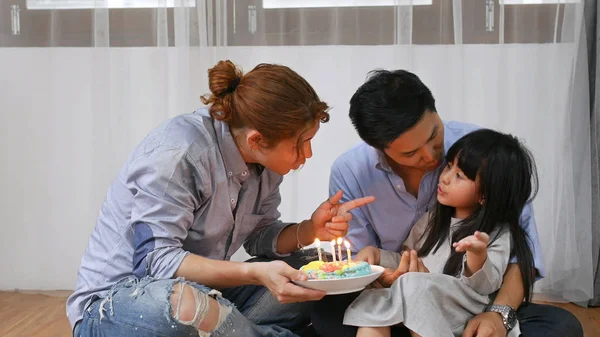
(249, 122), (320, 175)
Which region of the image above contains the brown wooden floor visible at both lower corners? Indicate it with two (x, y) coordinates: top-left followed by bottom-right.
(0, 291), (600, 337)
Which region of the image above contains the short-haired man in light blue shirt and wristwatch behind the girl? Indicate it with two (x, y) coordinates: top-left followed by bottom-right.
(312, 70), (583, 337)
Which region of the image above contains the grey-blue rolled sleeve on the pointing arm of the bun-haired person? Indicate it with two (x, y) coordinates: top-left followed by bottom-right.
(244, 177), (292, 258)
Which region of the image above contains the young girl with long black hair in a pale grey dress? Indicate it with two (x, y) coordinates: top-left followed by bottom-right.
(344, 129), (537, 337)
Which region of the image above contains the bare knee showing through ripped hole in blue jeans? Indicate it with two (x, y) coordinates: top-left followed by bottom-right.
(171, 282), (232, 332)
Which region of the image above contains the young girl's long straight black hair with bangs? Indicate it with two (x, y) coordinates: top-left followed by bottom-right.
(419, 129), (538, 301)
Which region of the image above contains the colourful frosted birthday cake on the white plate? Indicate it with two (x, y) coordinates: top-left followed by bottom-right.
(300, 261), (371, 280)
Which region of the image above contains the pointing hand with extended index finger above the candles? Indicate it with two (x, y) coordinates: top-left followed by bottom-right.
(310, 191), (375, 241)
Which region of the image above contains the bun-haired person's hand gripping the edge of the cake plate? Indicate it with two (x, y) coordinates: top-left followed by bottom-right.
(248, 261), (326, 303)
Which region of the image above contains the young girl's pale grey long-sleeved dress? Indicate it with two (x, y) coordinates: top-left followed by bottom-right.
(344, 214), (520, 337)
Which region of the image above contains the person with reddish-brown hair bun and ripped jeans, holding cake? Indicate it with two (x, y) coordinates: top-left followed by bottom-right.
(67, 61), (374, 336)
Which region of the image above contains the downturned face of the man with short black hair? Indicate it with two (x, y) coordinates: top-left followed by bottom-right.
(383, 112), (444, 172)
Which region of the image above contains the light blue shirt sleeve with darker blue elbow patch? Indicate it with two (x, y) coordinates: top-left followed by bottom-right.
(126, 147), (202, 278)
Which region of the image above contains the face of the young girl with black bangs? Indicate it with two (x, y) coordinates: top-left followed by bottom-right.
(437, 156), (483, 219)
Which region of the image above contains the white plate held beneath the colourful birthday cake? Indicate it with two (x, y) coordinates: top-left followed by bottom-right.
(292, 265), (383, 295)
